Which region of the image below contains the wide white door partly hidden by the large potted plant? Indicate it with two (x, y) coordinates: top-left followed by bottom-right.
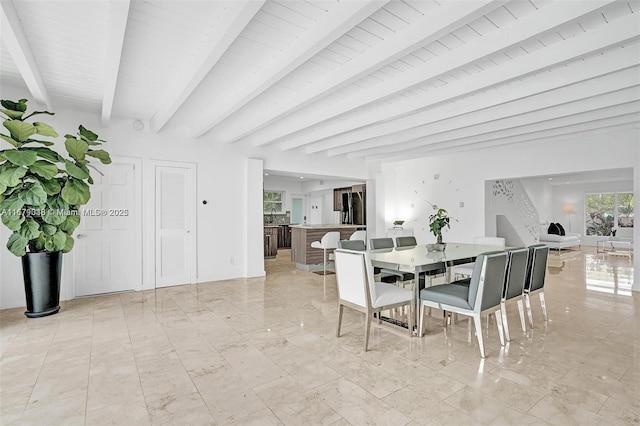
(73, 158), (142, 296)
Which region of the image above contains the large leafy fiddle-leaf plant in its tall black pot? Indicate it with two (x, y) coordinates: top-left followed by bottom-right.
(0, 99), (111, 317)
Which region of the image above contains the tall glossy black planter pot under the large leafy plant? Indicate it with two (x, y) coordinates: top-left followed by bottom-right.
(22, 251), (62, 318)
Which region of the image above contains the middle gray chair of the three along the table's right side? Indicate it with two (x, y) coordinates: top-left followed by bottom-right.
(500, 247), (529, 342)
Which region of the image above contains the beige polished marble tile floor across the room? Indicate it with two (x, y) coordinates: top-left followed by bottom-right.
(0, 248), (640, 425)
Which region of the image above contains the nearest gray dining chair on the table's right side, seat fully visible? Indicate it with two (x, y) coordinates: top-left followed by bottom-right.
(418, 252), (507, 358)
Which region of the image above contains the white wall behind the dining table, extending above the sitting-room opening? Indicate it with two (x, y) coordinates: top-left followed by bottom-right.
(375, 129), (640, 285)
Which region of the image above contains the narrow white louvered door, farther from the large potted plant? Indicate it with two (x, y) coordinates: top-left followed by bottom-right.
(155, 163), (196, 287)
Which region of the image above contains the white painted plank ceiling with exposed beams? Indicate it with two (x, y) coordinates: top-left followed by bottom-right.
(0, 0), (640, 161)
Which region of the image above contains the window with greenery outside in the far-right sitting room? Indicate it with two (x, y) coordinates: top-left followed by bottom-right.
(585, 192), (634, 236)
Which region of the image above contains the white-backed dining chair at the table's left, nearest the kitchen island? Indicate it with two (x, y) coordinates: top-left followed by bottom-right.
(334, 249), (413, 352)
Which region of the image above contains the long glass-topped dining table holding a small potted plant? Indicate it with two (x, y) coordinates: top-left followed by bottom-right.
(367, 243), (504, 330)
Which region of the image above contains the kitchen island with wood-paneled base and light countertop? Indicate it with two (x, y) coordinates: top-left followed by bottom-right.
(291, 224), (367, 271)
